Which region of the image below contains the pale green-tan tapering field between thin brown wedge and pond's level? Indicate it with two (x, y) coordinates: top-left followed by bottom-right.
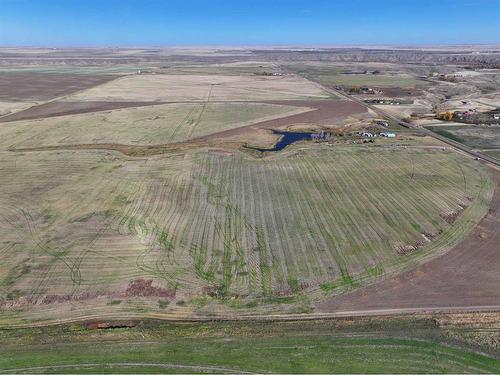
(0, 102), (311, 148)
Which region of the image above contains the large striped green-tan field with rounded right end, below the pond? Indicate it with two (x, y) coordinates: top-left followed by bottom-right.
(0, 146), (494, 324)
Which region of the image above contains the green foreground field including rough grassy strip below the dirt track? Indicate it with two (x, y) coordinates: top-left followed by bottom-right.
(0, 314), (500, 374)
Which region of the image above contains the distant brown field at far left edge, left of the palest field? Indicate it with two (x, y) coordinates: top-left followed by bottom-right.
(0, 73), (117, 101)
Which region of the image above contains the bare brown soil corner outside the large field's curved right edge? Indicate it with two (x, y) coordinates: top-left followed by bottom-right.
(317, 172), (500, 312)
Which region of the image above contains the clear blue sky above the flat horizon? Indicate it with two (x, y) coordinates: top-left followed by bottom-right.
(0, 0), (500, 46)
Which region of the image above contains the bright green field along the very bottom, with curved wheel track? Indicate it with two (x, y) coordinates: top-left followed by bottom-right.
(0, 336), (500, 373)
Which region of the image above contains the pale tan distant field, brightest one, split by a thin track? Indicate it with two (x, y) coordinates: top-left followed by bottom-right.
(68, 74), (331, 101)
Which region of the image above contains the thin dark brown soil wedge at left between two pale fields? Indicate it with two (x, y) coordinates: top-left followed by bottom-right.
(0, 102), (162, 122)
